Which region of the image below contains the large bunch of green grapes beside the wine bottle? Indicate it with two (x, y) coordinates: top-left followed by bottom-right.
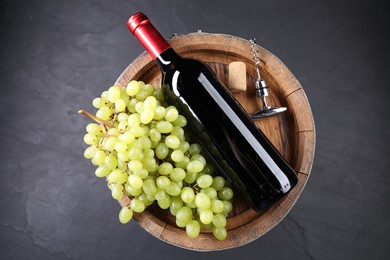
(84, 80), (233, 240)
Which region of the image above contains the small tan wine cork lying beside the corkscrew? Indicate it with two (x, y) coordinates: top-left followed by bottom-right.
(228, 61), (246, 92)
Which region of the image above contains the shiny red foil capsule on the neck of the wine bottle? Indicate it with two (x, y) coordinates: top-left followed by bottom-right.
(127, 12), (171, 60)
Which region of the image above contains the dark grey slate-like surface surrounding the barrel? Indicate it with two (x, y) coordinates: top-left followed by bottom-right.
(0, 0), (390, 260)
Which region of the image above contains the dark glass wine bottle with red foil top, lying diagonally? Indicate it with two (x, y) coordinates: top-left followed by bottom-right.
(127, 12), (298, 211)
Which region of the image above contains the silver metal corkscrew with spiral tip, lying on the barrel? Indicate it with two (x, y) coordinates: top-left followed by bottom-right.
(250, 38), (287, 119)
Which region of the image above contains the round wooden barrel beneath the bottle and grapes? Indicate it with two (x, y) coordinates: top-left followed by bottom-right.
(116, 33), (315, 251)
